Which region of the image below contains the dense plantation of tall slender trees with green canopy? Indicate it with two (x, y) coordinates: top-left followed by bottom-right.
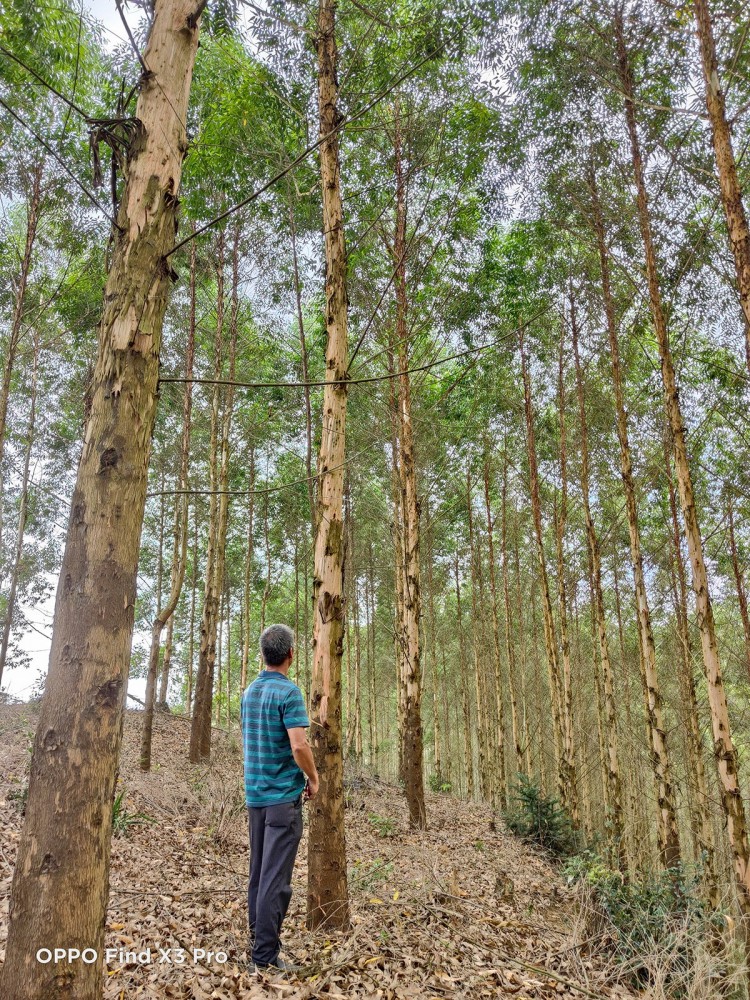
(0, 0), (750, 1000)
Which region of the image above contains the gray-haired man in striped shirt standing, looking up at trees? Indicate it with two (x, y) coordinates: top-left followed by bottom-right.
(241, 625), (318, 971)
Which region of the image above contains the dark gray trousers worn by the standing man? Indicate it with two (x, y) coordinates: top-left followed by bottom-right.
(247, 795), (302, 965)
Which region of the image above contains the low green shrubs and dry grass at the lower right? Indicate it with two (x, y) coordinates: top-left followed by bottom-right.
(504, 776), (748, 1000)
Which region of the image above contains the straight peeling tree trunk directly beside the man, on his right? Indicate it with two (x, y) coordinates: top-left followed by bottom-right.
(307, 0), (349, 929)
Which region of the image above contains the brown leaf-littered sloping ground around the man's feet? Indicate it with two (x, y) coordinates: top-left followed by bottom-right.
(0, 705), (633, 1000)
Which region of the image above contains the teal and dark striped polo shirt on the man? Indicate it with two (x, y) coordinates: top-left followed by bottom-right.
(241, 670), (310, 806)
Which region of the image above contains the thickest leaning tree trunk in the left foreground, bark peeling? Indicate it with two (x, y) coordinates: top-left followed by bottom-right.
(0, 0), (199, 1000)
